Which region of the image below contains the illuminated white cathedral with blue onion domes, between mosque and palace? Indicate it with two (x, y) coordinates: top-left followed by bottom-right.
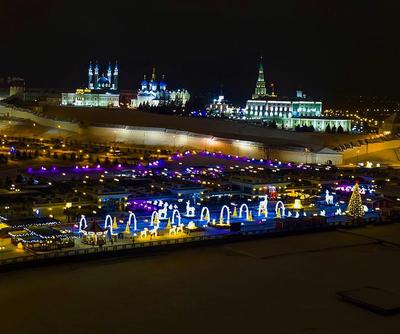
(131, 67), (190, 108)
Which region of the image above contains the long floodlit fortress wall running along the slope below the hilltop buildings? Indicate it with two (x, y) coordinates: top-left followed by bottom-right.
(0, 105), (342, 164)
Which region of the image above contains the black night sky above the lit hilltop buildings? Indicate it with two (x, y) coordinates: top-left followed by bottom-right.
(0, 0), (400, 102)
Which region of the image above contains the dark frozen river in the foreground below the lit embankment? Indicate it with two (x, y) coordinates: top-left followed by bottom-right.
(0, 224), (400, 334)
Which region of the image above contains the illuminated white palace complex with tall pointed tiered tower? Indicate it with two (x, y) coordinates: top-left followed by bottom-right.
(243, 59), (351, 132)
